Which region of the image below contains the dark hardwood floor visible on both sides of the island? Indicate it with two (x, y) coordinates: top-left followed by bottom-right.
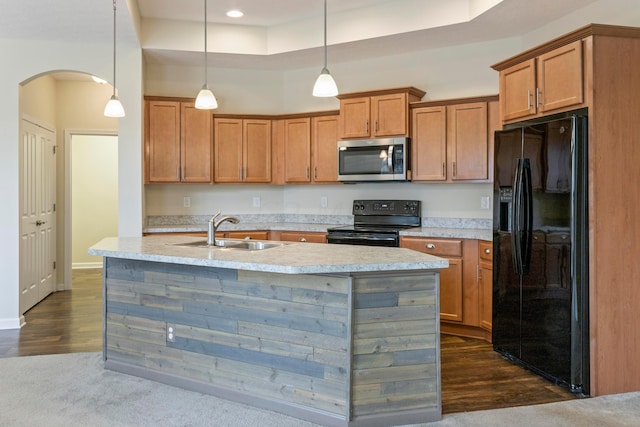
(0, 269), (575, 414)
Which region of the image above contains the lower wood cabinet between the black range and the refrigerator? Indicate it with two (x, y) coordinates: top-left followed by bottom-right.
(400, 236), (493, 341)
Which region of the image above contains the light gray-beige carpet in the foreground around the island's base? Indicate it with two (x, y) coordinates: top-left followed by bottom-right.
(0, 353), (640, 427)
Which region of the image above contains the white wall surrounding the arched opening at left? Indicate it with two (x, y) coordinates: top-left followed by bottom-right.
(0, 39), (142, 329)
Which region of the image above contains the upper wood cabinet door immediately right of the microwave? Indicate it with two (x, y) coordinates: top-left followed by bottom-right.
(411, 106), (447, 181)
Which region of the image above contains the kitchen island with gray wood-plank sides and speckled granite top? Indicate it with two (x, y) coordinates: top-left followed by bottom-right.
(89, 236), (448, 426)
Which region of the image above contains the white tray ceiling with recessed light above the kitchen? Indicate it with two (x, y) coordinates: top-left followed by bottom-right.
(0, 0), (596, 69)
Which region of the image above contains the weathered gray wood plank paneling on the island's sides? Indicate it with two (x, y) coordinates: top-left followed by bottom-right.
(105, 258), (440, 425)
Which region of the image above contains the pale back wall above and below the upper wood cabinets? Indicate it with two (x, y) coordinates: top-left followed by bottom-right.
(145, 0), (640, 224)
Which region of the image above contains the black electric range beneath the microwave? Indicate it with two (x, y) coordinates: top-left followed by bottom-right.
(327, 200), (421, 247)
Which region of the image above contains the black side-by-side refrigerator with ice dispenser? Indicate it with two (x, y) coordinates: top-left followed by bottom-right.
(492, 110), (589, 396)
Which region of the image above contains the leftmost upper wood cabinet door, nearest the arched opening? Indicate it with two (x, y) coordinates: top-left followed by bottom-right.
(147, 101), (180, 182)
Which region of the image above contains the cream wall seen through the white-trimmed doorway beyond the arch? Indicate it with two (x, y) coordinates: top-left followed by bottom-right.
(71, 135), (118, 268)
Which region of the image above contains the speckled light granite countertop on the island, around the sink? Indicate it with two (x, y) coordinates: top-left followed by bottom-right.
(89, 235), (449, 274)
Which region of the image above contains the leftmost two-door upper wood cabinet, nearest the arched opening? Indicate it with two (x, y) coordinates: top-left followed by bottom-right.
(144, 100), (213, 183)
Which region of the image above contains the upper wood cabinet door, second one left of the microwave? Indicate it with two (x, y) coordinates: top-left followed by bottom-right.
(284, 118), (311, 182)
